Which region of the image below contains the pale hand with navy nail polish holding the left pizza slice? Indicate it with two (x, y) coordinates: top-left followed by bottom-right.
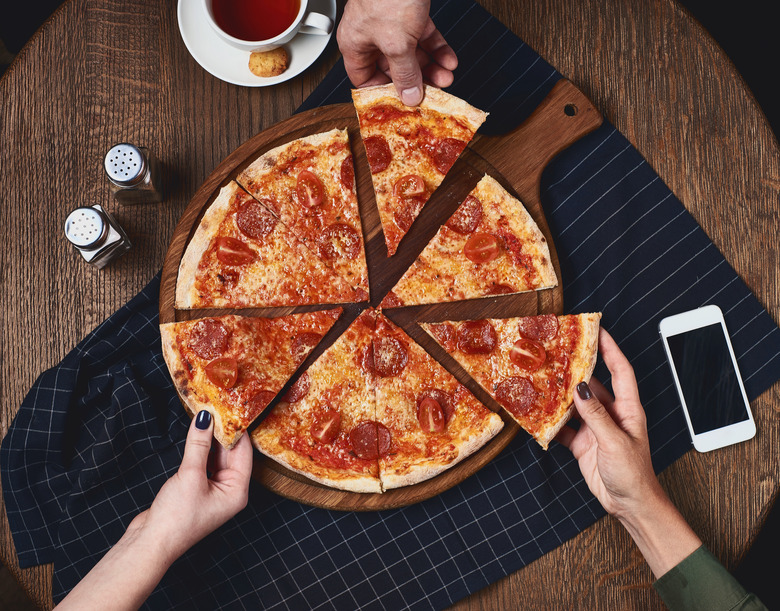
(133, 410), (252, 559)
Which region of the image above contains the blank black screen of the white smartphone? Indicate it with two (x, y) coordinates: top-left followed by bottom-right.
(667, 323), (748, 435)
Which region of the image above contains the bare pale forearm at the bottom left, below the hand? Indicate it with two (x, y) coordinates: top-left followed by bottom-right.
(57, 514), (175, 610)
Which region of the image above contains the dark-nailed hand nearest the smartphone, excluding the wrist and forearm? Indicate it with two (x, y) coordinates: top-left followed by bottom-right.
(556, 329), (666, 520)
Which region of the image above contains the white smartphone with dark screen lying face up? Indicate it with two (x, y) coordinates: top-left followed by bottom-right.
(658, 305), (756, 452)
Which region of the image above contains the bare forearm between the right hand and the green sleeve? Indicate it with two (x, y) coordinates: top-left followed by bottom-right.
(619, 489), (702, 579)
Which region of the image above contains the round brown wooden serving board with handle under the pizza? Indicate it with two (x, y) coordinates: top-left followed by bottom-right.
(160, 80), (601, 511)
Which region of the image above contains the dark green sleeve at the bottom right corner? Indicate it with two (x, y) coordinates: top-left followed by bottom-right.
(653, 545), (766, 611)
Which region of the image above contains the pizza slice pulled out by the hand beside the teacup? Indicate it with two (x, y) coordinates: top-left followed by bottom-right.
(352, 84), (487, 256)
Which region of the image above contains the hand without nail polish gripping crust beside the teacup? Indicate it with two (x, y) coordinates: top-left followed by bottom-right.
(336, 0), (458, 106)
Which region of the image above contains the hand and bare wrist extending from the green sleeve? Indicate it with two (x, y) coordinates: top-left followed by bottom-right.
(556, 329), (701, 577)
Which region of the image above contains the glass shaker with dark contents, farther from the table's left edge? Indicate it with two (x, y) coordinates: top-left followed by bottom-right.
(103, 142), (162, 206)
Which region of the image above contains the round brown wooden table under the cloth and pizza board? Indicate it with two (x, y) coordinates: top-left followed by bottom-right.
(0, 0), (780, 609)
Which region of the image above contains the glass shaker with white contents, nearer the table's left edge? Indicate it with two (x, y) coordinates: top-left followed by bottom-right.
(65, 204), (130, 269)
